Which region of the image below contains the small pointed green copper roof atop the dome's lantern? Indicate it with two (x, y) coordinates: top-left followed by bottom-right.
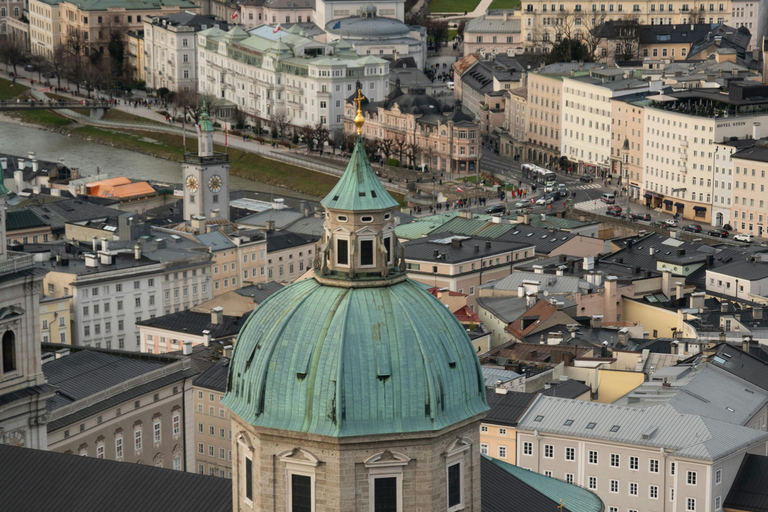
(320, 137), (398, 212)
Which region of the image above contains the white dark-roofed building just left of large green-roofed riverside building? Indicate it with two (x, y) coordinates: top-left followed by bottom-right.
(144, 11), (227, 91)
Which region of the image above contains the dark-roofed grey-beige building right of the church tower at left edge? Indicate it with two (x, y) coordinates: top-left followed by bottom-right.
(43, 345), (198, 471)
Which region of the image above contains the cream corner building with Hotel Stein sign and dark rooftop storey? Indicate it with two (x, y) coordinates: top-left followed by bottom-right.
(642, 82), (768, 223)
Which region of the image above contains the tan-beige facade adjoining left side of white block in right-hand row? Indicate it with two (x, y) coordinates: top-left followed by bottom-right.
(525, 73), (563, 166)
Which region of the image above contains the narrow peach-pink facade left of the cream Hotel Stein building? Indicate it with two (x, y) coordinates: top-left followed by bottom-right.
(611, 99), (644, 201)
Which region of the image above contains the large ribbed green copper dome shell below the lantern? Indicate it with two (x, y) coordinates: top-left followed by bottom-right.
(224, 279), (488, 437)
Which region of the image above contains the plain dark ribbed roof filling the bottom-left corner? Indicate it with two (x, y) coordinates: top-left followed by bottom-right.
(0, 445), (232, 512)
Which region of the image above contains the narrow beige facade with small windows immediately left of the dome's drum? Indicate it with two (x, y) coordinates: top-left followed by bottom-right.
(187, 386), (233, 478)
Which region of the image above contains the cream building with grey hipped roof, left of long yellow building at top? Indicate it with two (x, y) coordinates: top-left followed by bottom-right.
(464, 9), (523, 56)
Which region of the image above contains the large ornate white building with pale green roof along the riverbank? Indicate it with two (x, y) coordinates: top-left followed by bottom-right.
(197, 25), (389, 130)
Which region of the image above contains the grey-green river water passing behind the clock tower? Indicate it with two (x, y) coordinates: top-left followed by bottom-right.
(0, 119), (318, 204)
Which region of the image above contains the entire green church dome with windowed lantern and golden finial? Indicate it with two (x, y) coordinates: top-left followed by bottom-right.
(224, 107), (488, 437)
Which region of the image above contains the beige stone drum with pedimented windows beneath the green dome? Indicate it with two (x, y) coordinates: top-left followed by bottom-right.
(232, 414), (480, 512)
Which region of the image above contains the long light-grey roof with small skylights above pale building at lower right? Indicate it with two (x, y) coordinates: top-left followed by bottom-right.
(517, 395), (768, 461)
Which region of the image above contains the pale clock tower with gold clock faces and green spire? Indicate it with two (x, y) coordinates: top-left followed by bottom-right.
(182, 100), (229, 220)
